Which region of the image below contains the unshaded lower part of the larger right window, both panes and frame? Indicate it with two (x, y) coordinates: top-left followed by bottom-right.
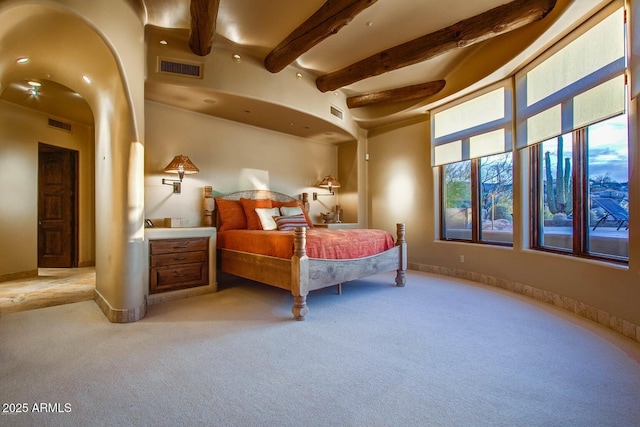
(532, 114), (629, 261)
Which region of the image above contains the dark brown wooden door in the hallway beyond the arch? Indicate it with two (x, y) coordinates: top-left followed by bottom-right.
(38, 144), (78, 268)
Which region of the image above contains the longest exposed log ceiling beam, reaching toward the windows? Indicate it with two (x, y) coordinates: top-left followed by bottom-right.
(316, 0), (556, 92)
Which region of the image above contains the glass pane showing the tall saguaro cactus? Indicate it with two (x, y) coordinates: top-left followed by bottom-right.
(540, 134), (573, 250)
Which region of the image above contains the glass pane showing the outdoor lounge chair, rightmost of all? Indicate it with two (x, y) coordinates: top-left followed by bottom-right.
(587, 114), (629, 259)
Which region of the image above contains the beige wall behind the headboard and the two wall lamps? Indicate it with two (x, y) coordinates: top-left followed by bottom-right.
(145, 101), (337, 226)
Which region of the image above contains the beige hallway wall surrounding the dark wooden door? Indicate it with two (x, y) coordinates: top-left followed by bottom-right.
(0, 101), (95, 277)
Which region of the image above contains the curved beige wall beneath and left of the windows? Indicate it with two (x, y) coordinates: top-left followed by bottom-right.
(368, 105), (640, 325)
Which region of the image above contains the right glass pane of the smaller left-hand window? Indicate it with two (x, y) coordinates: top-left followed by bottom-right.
(480, 153), (513, 243)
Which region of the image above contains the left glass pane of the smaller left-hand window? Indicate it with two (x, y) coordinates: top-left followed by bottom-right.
(443, 160), (471, 240)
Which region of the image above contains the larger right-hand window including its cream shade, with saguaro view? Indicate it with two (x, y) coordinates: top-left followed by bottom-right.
(516, 3), (629, 262)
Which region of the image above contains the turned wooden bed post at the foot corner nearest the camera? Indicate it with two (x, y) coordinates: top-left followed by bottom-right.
(291, 227), (309, 320)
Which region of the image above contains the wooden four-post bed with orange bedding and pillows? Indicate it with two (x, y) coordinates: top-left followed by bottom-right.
(216, 190), (407, 320)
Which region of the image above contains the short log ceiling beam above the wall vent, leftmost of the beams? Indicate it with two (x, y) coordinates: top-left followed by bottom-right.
(189, 0), (220, 56)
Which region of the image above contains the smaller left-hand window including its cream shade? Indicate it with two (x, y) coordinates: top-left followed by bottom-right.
(431, 80), (513, 245)
